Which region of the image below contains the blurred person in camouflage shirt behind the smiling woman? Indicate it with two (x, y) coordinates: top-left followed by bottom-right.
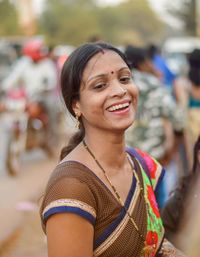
(125, 46), (184, 208)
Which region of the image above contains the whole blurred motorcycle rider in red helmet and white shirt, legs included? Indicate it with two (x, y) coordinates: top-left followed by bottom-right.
(2, 37), (57, 139)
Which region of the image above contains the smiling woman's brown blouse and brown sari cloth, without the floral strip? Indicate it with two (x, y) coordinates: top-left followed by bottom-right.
(41, 157), (147, 257)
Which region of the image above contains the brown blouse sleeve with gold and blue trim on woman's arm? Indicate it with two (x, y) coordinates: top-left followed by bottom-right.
(40, 164), (96, 231)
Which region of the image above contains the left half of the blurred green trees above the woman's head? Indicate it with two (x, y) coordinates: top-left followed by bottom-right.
(39, 0), (100, 46)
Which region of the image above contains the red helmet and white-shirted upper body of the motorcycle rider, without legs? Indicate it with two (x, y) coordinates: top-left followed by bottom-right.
(2, 37), (57, 101)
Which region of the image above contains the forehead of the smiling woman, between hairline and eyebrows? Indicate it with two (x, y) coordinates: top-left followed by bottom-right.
(83, 50), (127, 78)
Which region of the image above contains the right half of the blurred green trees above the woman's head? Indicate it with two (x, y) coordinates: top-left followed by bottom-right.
(96, 0), (164, 45)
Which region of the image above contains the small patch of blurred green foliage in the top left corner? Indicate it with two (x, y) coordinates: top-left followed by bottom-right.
(0, 0), (19, 36)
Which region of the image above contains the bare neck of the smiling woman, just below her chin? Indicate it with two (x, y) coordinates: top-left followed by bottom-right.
(84, 129), (127, 170)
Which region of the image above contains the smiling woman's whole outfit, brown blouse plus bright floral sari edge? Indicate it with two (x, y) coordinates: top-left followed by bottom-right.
(41, 147), (164, 257)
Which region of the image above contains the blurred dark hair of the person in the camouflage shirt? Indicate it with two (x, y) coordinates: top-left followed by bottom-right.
(125, 45), (148, 69)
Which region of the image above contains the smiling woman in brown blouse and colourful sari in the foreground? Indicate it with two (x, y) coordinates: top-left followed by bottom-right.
(41, 43), (184, 257)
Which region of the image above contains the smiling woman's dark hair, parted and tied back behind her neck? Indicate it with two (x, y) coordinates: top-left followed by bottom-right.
(60, 42), (130, 160)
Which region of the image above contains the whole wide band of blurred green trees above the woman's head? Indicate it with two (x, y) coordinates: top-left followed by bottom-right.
(39, 0), (164, 46)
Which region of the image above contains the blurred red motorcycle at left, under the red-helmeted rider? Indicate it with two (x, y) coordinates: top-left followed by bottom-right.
(5, 88), (53, 176)
